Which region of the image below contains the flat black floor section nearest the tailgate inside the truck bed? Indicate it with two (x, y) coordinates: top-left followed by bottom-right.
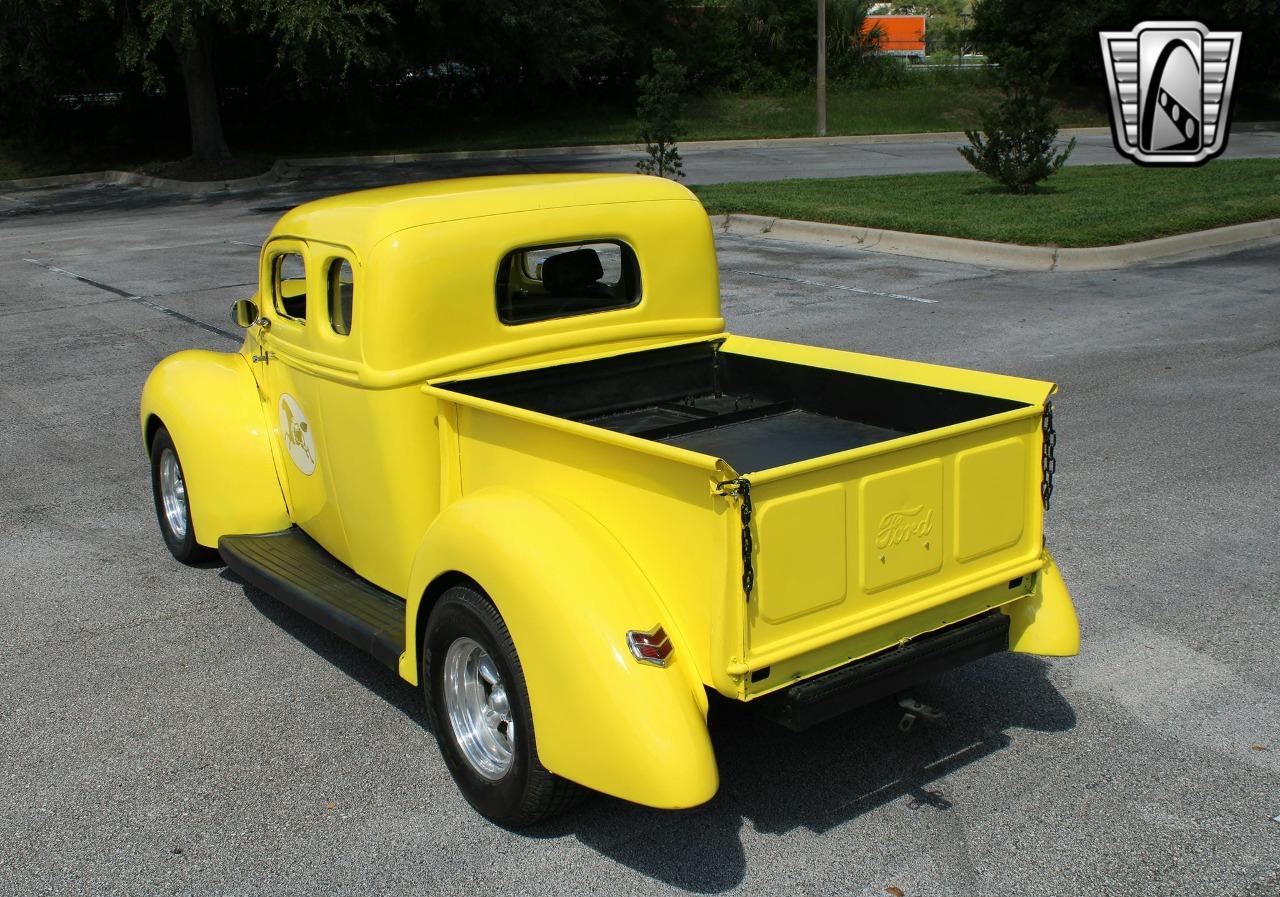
(658, 408), (904, 473)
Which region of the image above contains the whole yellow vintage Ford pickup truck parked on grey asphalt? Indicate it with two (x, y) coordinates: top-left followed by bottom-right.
(141, 175), (1079, 827)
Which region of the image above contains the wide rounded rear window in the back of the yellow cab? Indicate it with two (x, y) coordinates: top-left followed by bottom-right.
(497, 241), (640, 324)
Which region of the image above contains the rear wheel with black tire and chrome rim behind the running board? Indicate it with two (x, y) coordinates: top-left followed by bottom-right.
(421, 586), (584, 828)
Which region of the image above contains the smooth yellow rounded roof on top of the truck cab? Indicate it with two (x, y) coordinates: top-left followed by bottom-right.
(263, 174), (696, 253)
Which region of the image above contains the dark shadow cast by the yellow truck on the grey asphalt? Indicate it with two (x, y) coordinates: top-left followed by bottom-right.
(220, 569), (1076, 893)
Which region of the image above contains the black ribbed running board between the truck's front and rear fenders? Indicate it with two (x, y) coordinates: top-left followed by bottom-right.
(218, 527), (404, 669)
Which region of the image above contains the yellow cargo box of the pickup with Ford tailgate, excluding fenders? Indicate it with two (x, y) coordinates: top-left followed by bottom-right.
(424, 335), (1053, 700)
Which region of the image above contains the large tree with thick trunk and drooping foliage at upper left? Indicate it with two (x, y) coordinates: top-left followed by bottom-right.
(109, 0), (390, 161)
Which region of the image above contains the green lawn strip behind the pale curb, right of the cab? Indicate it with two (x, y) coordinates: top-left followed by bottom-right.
(695, 159), (1280, 247)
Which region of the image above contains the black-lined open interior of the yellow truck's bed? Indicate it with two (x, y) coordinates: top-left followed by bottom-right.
(440, 340), (1025, 473)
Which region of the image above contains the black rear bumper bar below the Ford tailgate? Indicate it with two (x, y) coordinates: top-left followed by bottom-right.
(751, 610), (1009, 732)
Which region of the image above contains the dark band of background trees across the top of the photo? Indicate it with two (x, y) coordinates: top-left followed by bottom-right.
(0, 0), (1280, 167)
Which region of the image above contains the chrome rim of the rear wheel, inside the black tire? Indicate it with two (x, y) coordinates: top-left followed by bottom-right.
(443, 639), (516, 782)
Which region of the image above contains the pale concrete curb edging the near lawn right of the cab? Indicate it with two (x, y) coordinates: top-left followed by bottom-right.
(712, 214), (1280, 271)
